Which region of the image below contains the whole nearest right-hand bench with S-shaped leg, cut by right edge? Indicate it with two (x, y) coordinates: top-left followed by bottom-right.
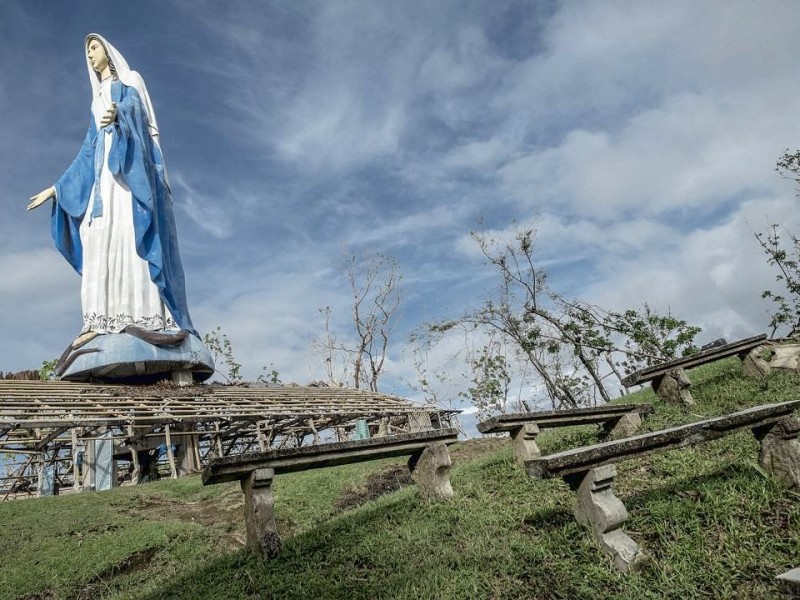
(525, 400), (800, 572)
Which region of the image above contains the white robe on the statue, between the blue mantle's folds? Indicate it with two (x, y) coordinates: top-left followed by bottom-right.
(80, 77), (177, 333)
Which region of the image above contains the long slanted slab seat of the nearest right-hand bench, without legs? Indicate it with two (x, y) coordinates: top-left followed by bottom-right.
(525, 400), (800, 478)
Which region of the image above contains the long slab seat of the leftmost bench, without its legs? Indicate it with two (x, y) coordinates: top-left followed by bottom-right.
(203, 429), (458, 485)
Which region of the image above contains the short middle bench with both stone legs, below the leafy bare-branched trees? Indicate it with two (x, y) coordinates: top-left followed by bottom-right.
(478, 404), (654, 464)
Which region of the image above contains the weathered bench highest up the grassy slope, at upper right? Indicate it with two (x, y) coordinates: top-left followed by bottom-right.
(622, 334), (767, 405)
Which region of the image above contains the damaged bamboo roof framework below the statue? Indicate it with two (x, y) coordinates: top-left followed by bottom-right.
(0, 380), (458, 500)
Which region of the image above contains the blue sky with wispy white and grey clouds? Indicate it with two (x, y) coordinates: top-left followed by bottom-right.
(0, 0), (800, 422)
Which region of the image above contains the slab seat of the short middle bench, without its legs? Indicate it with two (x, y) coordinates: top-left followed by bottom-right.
(478, 404), (655, 433)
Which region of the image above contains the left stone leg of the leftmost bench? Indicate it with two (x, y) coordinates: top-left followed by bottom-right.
(242, 469), (281, 559)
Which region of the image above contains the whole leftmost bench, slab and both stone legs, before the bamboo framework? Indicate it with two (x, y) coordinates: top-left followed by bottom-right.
(203, 429), (458, 558)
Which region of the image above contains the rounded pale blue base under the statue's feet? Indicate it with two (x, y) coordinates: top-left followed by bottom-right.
(61, 333), (214, 384)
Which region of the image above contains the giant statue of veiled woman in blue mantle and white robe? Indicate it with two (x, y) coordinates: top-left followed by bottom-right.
(28, 33), (213, 379)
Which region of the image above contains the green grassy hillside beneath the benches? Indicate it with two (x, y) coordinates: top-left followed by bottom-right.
(0, 359), (800, 600)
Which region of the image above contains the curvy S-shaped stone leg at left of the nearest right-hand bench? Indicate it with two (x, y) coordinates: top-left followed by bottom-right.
(564, 465), (645, 573)
